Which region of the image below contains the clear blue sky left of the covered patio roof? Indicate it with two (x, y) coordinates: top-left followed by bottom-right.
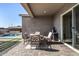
(0, 3), (28, 28)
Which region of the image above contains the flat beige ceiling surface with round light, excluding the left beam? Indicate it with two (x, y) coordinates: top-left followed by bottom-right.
(29, 3), (64, 16)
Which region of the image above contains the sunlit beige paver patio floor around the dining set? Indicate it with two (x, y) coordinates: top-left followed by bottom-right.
(3, 42), (79, 56)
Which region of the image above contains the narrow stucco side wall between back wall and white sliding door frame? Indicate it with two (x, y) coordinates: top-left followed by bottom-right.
(53, 4), (75, 39)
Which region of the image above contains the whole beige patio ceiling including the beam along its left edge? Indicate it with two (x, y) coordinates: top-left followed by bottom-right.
(21, 3), (75, 17)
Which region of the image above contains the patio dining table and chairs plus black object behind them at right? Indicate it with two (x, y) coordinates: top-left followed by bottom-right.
(23, 28), (58, 47)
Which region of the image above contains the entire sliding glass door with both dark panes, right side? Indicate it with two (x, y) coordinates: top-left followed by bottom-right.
(62, 5), (79, 49)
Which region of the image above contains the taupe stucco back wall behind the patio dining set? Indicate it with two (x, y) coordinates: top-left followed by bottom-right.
(22, 16), (53, 35)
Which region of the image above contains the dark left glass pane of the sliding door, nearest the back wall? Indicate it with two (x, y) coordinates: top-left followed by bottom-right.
(63, 11), (72, 44)
